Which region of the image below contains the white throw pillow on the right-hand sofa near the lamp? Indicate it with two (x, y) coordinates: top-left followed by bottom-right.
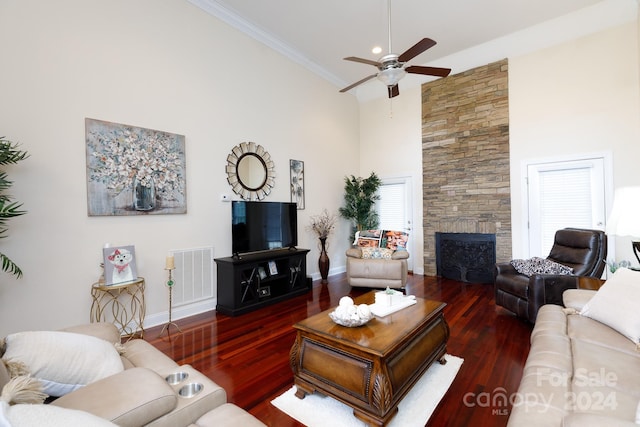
(580, 268), (640, 344)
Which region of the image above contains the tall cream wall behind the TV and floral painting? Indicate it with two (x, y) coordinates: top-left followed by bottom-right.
(0, 0), (359, 336)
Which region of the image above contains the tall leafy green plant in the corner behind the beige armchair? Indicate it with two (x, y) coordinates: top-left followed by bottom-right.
(338, 172), (382, 239)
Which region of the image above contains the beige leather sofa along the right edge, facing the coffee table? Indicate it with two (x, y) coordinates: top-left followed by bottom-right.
(508, 283), (640, 427)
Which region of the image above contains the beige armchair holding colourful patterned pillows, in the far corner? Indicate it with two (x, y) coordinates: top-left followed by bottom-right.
(347, 247), (409, 289)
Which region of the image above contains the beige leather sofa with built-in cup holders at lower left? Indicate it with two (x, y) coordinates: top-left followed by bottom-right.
(0, 323), (264, 427)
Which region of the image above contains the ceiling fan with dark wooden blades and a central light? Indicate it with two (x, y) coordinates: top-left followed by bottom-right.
(340, 0), (451, 98)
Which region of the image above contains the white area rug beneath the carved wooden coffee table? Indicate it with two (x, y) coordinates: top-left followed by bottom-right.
(271, 354), (463, 427)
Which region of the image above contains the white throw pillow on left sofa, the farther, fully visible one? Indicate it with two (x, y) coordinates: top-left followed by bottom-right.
(3, 331), (124, 396)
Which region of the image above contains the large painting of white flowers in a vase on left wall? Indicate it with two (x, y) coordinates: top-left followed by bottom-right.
(85, 118), (187, 216)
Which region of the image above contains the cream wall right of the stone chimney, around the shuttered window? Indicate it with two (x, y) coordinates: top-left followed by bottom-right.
(509, 22), (640, 264)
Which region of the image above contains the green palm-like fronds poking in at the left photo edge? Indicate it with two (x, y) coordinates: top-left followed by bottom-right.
(0, 137), (29, 277)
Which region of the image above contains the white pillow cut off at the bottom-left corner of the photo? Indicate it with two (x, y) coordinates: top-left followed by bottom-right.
(0, 402), (116, 427)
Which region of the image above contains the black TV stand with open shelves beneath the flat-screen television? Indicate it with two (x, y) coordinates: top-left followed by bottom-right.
(214, 248), (311, 316)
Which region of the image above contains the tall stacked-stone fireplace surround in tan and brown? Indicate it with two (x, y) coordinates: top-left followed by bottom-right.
(422, 59), (511, 280)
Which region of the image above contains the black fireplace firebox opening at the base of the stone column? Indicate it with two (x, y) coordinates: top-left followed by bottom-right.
(436, 232), (496, 283)
